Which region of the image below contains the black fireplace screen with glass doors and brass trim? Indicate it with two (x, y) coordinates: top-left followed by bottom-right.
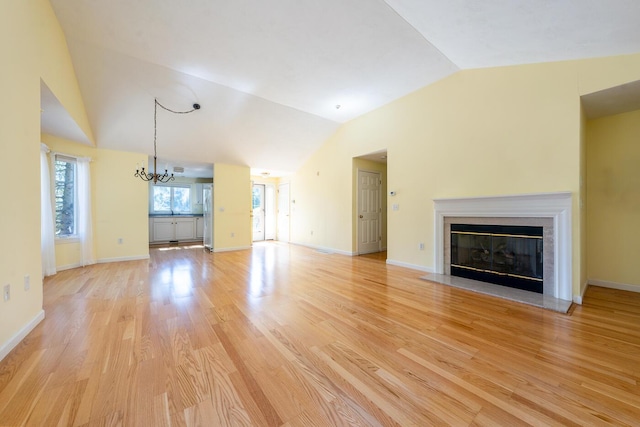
(451, 224), (543, 293)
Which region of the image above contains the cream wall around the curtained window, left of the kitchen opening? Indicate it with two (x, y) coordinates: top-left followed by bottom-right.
(42, 134), (149, 268)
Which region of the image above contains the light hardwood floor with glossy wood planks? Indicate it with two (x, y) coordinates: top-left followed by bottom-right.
(0, 243), (640, 426)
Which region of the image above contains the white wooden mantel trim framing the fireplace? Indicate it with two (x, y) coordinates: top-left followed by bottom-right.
(433, 191), (573, 301)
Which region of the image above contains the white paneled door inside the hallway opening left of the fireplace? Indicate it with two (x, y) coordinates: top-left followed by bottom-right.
(358, 170), (382, 254)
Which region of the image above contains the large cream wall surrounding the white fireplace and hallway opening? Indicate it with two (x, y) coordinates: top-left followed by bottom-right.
(292, 55), (640, 295)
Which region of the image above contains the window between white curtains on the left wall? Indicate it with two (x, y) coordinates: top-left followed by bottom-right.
(54, 154), (78, 238)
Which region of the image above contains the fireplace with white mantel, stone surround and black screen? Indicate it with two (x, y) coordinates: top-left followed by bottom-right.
(431, 192), (572, 304)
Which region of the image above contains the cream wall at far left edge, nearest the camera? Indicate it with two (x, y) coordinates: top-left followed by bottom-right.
(0, 0), (91, 357)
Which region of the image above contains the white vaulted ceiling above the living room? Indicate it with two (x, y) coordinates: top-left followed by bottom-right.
(43, 0), (640, 176)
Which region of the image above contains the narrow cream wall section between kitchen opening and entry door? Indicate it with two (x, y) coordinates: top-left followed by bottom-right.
(213, 163), (251, 251)
